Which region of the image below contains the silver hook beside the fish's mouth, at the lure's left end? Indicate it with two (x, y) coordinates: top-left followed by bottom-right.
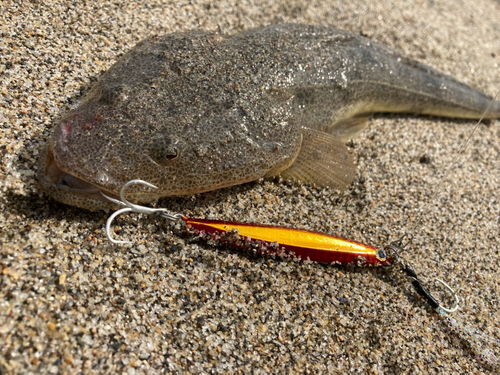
(101, 180), (184, 244)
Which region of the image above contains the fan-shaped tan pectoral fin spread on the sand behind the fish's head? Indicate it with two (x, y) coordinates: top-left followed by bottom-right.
(281, 127), (356, 190)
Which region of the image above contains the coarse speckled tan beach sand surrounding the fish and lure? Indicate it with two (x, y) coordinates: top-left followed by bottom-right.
(0, 0), (500, 374)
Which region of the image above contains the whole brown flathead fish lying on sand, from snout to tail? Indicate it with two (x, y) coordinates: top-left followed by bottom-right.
(37, 24), (500, 211)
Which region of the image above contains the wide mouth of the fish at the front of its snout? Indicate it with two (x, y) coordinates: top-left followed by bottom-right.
(37, 143), (116, 211)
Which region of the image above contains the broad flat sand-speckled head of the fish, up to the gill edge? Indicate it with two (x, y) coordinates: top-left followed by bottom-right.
(38, 32), (301, 210)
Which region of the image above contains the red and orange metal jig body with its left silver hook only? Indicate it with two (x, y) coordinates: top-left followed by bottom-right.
(103, 180), (390, 265)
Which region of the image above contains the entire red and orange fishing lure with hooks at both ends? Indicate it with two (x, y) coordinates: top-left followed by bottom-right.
(101, 180), (500, 366)
